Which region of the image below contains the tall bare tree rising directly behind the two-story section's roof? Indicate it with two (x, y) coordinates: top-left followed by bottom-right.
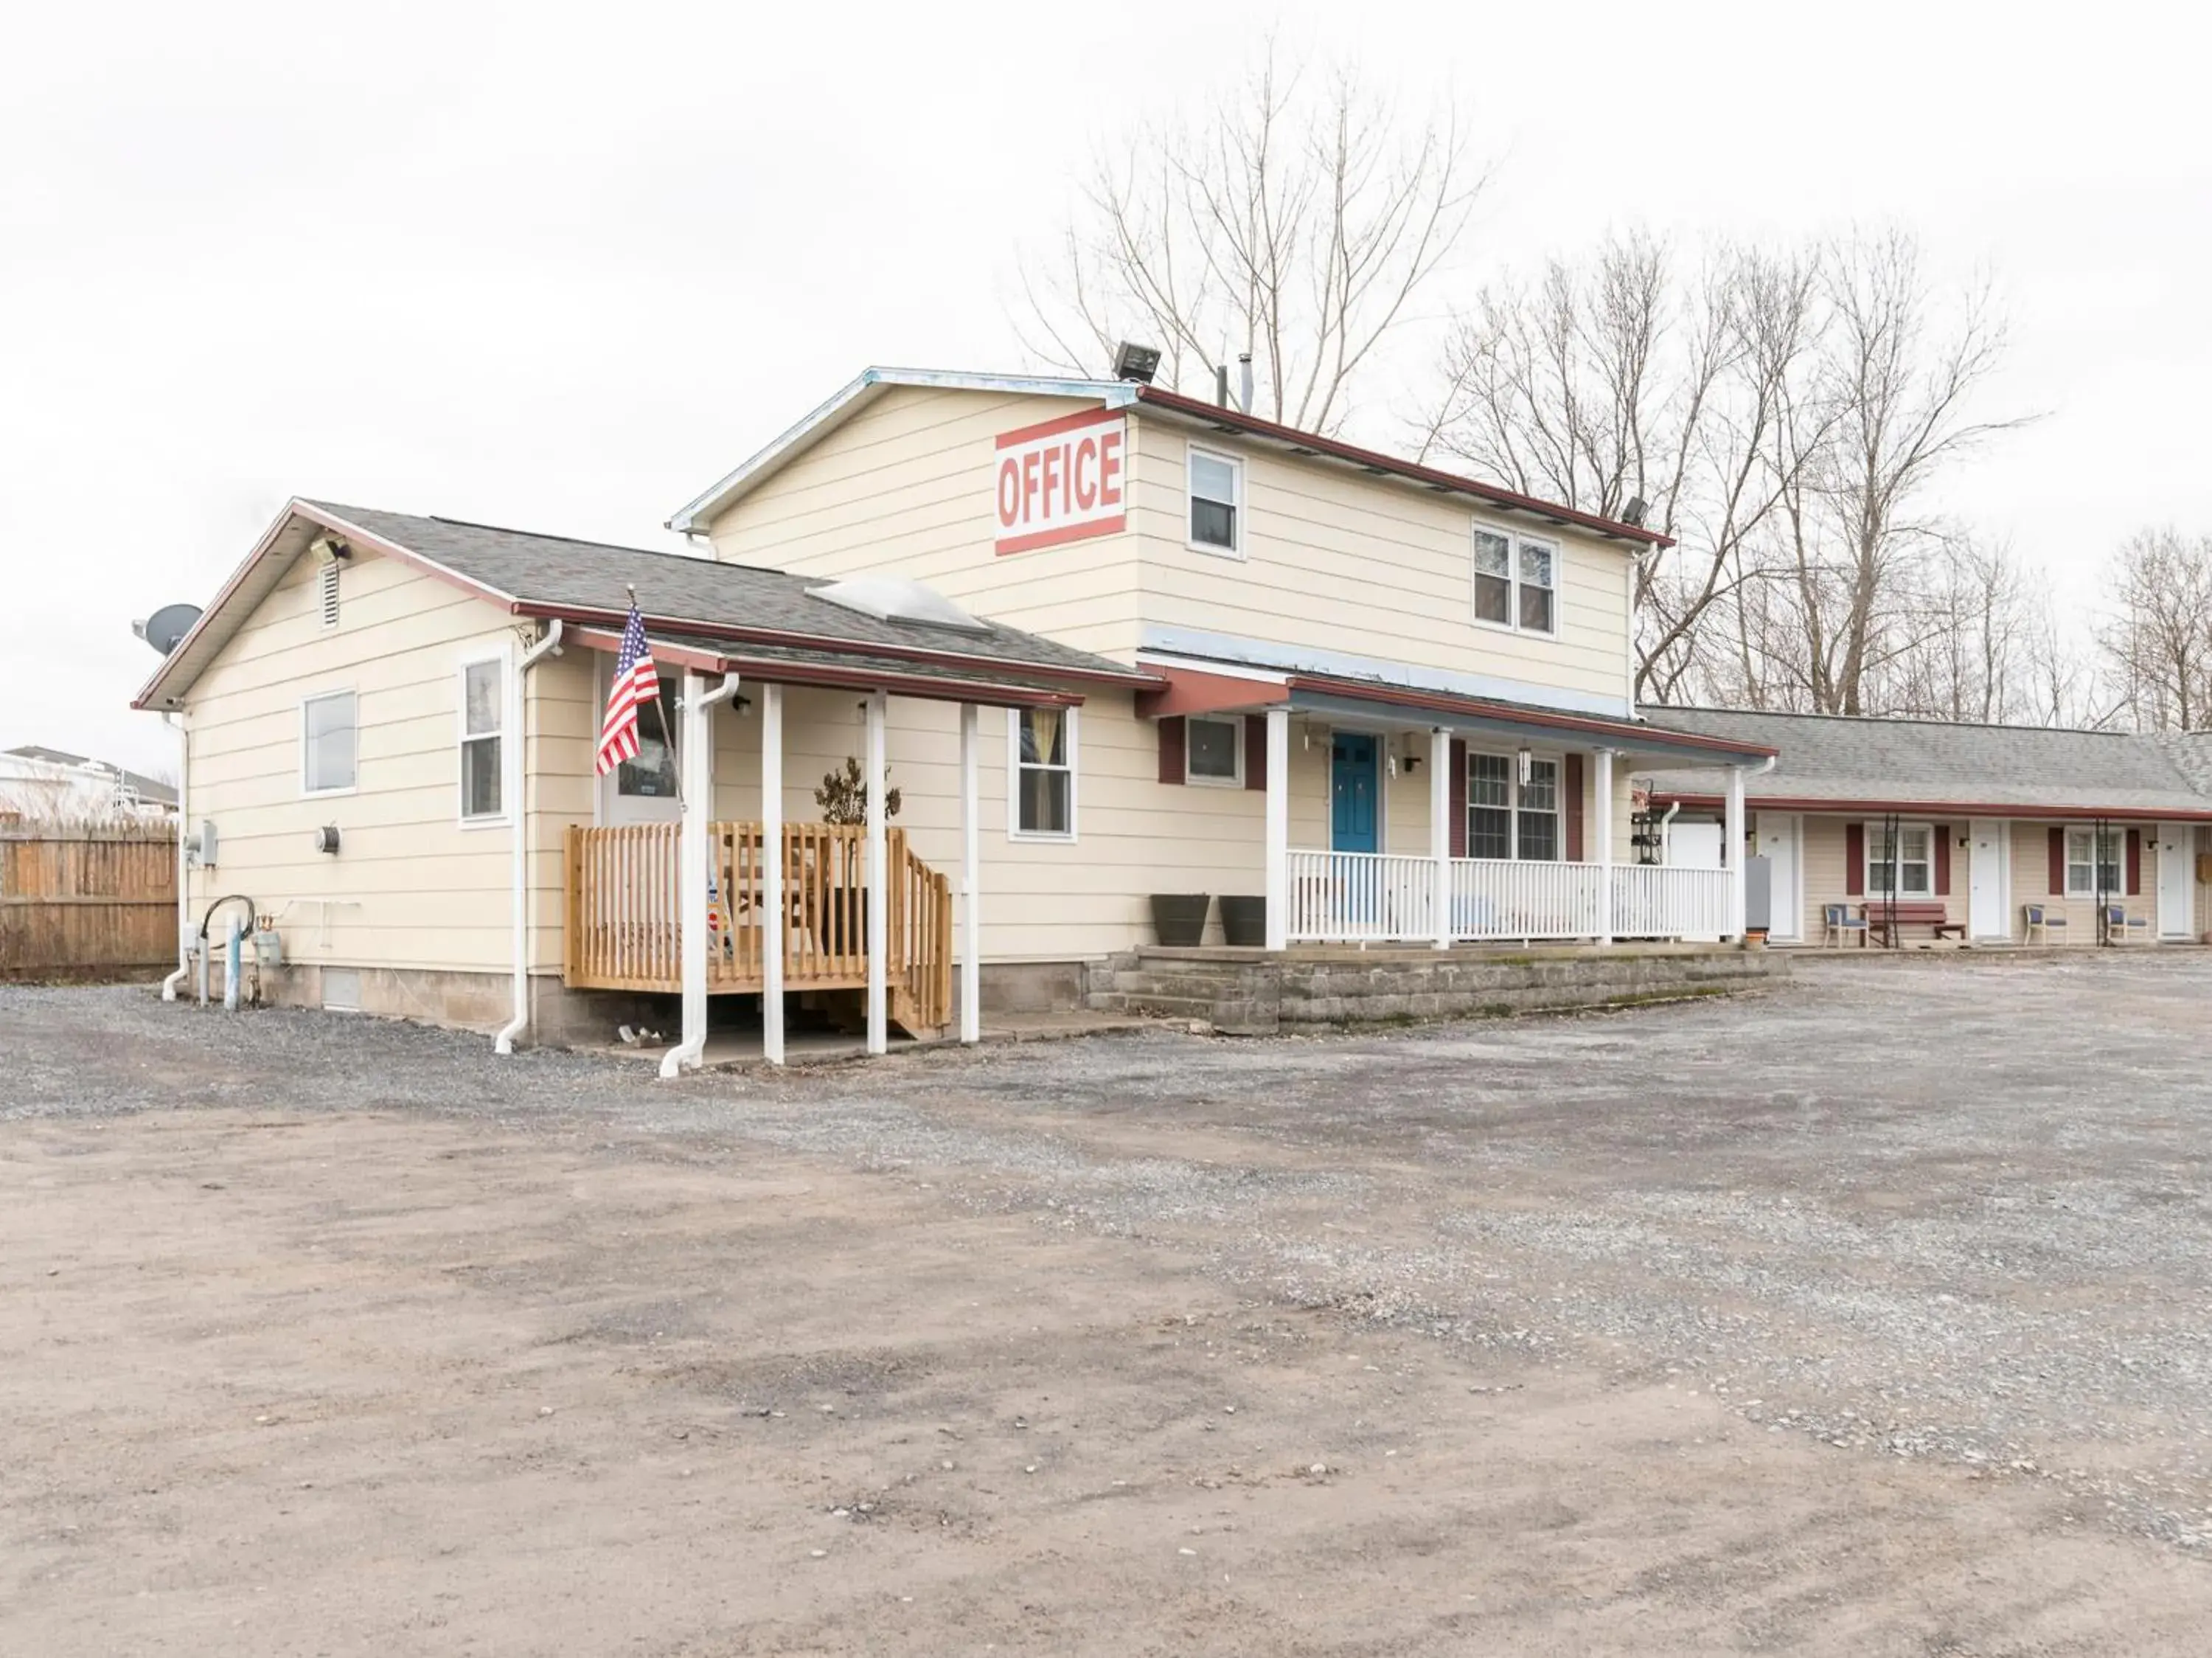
(1015, 44), (1482, 431)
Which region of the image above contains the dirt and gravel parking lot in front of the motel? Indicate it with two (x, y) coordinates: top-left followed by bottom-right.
(0, 952), (2212, 1658)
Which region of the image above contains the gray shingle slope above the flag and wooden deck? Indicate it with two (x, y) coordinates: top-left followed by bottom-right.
(316, 500), (1150, 681)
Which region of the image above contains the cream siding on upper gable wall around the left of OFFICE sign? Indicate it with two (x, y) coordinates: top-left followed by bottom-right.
(710, 387), (1141, 659)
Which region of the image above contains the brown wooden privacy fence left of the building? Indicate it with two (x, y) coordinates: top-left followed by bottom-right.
(0, 823), (177, 979)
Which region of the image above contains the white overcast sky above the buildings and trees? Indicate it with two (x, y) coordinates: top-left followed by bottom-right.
(0, 0), (2212, 766)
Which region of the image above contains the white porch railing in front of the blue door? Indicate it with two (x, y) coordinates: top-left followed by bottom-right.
(1287, 850), (1730, 943)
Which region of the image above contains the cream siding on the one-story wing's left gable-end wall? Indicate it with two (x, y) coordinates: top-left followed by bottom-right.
(184, 542), (513, 972)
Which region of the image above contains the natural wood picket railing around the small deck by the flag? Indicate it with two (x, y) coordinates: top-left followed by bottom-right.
(562, 823), (953, 1032)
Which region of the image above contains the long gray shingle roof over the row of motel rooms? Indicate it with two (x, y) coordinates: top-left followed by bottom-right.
(1639, 708), (2212, 816)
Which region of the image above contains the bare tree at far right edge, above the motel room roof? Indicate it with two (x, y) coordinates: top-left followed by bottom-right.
(2097, 529), (2212, 730)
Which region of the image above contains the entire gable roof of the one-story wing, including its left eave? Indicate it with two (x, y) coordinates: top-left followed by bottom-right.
(133, 500), (1155, 708)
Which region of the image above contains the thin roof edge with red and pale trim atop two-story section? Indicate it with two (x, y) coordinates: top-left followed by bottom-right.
(668, 367), (1674, 547)
